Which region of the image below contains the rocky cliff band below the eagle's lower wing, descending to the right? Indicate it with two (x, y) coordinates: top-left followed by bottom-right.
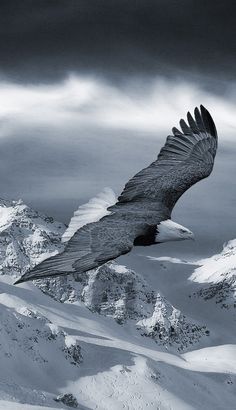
(36, 262), (209, 351)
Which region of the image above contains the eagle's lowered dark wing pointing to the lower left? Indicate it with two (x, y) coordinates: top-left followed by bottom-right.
(16, 216), (134, 283)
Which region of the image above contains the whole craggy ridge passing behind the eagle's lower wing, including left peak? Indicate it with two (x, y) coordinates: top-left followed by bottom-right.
(0, 201), (208, 350)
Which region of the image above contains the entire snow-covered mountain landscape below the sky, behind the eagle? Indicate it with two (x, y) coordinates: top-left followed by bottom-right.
(0, 201), (236, 410)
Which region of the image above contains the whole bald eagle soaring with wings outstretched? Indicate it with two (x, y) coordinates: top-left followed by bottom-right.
(16, 105), (217, 284)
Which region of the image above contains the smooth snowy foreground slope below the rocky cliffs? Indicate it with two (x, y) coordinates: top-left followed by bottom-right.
(0, 275), (236, 410)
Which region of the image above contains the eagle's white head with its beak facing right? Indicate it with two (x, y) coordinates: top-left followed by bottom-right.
(155, 219), (194, 243)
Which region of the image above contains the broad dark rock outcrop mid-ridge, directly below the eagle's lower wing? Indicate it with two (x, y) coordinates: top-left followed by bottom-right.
(81, 262), (155, 323)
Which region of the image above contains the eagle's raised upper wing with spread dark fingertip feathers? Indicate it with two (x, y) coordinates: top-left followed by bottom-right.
(117, 105), (217, 213)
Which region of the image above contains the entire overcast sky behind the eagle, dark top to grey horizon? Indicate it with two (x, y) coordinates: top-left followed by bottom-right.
(0, 0), (236, 260)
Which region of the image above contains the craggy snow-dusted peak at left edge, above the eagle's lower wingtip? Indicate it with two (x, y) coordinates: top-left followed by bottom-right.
(0, 200), (66, 275)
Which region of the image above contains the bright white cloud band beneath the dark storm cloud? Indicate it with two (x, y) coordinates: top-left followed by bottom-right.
(0, 75), (236, 142)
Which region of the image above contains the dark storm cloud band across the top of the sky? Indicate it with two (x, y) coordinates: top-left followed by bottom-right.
(0, 0), (236, 81)
